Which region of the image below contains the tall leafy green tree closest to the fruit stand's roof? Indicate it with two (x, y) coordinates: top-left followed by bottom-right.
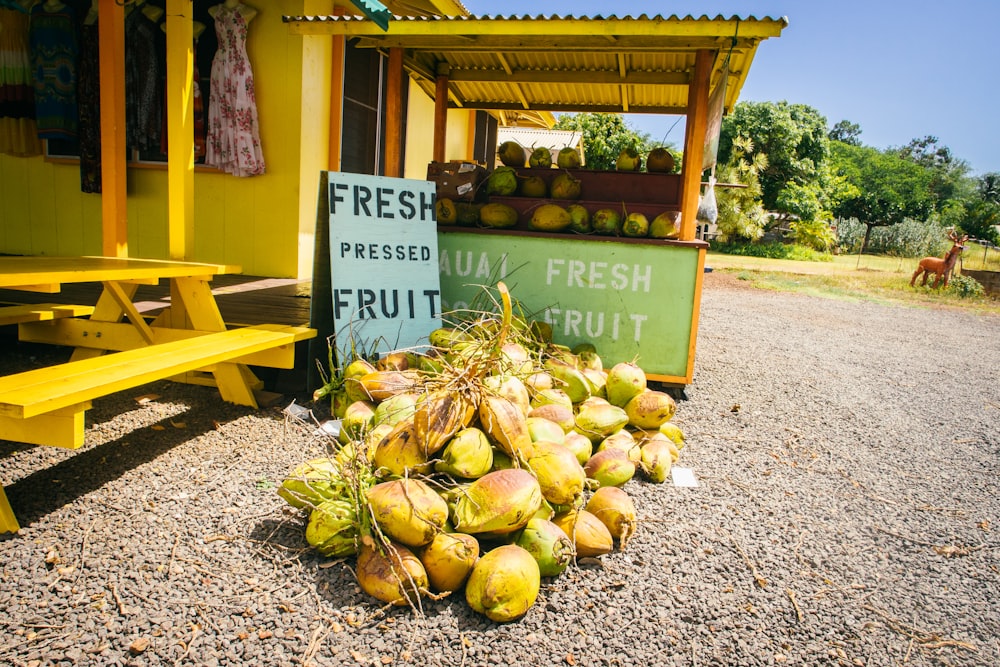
(719, 102), (830, 213)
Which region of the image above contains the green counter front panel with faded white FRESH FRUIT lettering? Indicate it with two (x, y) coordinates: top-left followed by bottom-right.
(438, 231), (704, 381)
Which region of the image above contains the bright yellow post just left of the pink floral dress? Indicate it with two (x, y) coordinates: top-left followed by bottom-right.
(166, 0), (194, 260)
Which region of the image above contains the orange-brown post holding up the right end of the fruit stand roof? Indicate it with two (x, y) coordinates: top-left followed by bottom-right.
(680, 49), (715, 241)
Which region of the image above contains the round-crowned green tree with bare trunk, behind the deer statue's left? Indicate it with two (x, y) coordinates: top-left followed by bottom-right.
(831, 141), (935, 252)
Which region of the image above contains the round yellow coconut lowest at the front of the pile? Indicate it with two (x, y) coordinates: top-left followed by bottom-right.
(465, 544), (542, 623)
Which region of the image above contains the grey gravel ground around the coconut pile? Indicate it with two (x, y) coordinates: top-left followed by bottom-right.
(0, 273), (1000, 666)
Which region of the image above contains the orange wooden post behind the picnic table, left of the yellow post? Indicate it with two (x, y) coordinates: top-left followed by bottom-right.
(98, 0), (128, 257)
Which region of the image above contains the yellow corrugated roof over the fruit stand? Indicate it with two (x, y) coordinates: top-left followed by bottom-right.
(283, 14), (788, 114)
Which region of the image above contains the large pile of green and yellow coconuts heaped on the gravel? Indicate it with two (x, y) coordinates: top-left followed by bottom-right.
(278, 283), (684, 622)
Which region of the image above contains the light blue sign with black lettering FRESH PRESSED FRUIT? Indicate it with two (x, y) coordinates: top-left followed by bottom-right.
(327, 172), (441, 353)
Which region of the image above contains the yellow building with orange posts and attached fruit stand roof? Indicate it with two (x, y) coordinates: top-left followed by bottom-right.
(0, 0), (786, 278)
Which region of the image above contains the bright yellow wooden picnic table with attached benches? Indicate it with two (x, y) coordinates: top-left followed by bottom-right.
(0, 257), (316, 532)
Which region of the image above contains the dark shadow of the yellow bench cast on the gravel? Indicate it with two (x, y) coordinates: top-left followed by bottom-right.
(0, 400), (245, 528)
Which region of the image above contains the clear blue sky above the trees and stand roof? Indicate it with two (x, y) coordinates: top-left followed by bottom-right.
(463, 0), (1000, 174)
